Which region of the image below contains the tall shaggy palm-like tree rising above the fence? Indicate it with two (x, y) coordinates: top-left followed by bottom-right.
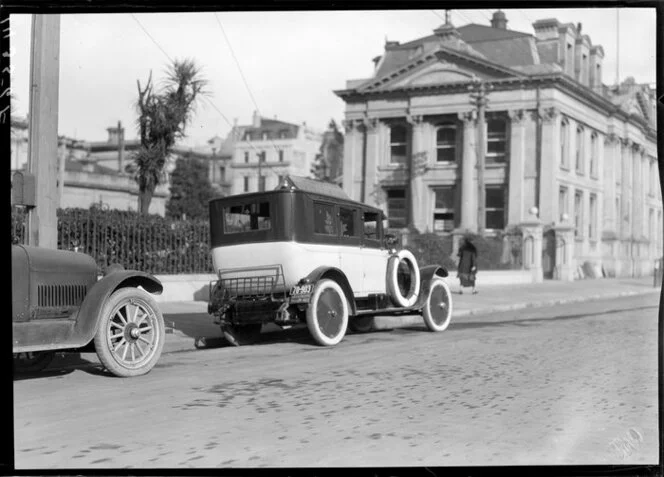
(134, 59), (208, 214)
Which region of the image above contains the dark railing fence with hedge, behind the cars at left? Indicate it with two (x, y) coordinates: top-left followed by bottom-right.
(12, 208), (212, 274)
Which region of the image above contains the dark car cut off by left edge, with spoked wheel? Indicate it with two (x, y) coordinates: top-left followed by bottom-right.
(12, 245), (165, 377)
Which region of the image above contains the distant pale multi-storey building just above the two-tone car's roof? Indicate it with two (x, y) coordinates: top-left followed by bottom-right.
(229, 112), (322, 194)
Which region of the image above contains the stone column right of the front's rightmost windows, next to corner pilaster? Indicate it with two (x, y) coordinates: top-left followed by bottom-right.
(507, 109), (524, 226)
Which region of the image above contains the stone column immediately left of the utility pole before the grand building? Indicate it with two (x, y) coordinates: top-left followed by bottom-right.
(459, 111), (477, 232)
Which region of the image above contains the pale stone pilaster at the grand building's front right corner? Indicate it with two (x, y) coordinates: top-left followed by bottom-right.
(537, 107), (560, 223)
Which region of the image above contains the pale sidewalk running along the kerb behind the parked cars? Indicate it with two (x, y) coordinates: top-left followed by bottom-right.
(160, 277), (661, 353)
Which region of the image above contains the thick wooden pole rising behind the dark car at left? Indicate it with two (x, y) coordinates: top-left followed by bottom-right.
(28, 15), (60, 249)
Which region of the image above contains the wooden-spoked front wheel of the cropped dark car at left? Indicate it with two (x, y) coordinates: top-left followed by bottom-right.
(94, 288), (165, 377)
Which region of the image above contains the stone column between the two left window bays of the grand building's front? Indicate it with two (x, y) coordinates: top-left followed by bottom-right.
(406, 114), (428, 232)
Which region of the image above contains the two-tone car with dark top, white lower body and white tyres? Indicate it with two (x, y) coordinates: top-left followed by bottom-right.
(208, 177), (452, 346)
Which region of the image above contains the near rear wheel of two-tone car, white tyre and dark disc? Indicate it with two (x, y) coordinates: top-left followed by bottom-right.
(307, 279), (348, 346)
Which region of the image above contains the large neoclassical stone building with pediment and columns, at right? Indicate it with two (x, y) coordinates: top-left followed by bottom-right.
(335, 11), (664, 279)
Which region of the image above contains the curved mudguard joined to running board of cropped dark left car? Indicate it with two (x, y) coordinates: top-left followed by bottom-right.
(14, 270), (163, 352)
